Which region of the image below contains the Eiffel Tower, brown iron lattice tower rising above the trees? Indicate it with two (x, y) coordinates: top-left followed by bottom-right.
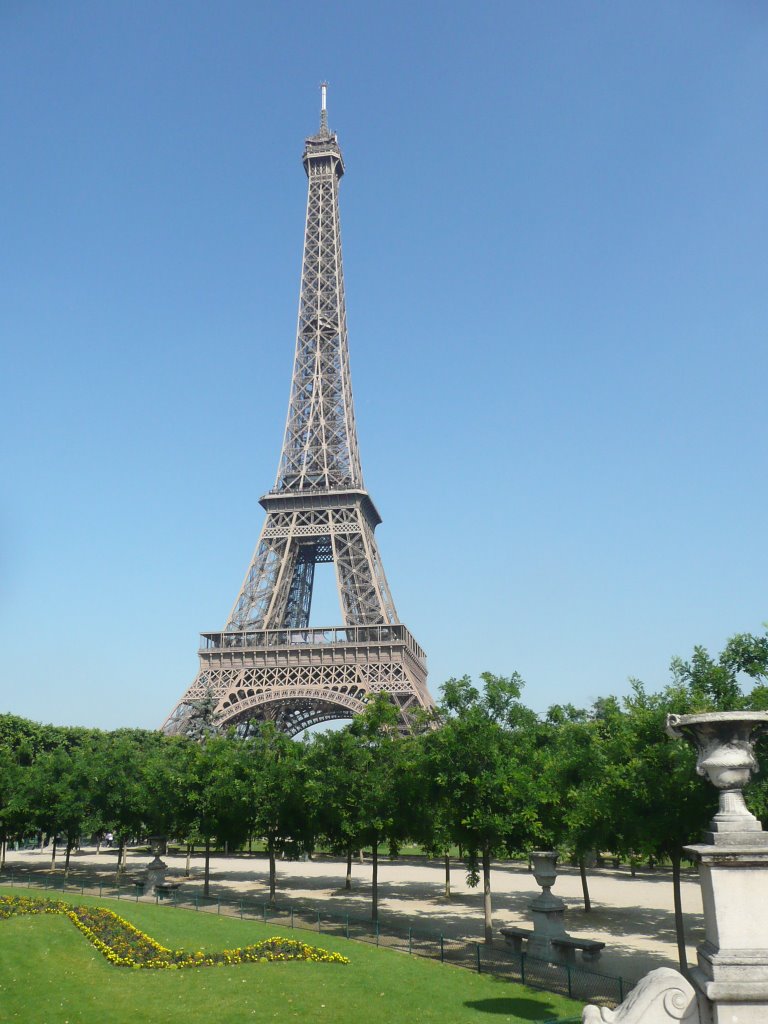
(162, 85), (433, 735)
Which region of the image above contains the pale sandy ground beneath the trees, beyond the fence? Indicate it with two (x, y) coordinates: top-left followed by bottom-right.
(6, 848), (703, 978)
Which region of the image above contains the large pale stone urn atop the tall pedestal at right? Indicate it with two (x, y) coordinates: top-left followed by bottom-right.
(667, 711), (768, 845)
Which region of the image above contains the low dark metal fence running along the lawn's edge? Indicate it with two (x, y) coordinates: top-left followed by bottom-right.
(0, 870), (635, 1007)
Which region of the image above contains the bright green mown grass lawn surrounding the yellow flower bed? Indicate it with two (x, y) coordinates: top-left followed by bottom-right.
(0, 887), (581, 1024)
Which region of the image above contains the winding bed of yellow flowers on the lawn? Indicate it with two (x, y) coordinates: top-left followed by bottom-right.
(0, 896), (349, 971)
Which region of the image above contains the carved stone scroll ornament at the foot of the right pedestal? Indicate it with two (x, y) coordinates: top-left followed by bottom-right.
(582, 967), (700, 1024)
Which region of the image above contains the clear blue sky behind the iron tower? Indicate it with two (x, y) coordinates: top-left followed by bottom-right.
(0, 0), (768, 728)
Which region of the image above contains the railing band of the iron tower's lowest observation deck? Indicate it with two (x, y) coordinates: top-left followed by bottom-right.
(200, 623), (427, 664)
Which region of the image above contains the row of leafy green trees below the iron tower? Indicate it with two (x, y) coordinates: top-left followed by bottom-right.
(0, 634), (768, 964)
